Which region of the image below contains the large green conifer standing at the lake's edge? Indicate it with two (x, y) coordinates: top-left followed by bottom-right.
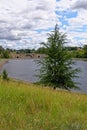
(38, 25), (79, 90)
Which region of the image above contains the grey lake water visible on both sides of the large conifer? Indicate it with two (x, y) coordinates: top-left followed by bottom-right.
(1, 59), (87, 93)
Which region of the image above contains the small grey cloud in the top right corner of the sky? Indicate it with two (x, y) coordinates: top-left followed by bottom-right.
(72, 0), (87, 10)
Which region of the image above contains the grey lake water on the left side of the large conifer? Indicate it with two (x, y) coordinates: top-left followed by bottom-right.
(2, 59), (39, 82)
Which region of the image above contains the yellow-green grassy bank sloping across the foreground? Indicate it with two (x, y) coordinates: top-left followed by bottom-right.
(0, 79), (87, 130)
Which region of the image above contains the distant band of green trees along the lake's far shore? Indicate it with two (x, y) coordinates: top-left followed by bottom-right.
(0, 45), (87, 58)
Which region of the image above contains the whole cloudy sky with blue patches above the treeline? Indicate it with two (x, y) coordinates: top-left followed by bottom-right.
(0, 0), (87, 49)
